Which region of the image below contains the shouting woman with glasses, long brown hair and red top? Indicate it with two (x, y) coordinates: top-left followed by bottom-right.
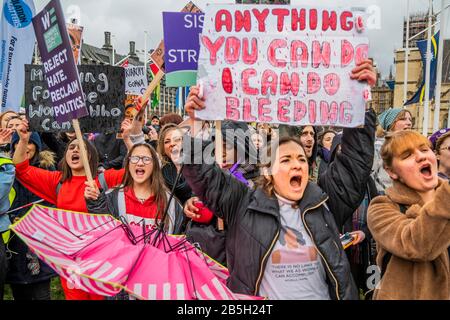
(85, 143), (184, 234)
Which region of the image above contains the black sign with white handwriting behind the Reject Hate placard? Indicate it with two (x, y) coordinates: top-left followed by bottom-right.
(25, 65), (125, 132)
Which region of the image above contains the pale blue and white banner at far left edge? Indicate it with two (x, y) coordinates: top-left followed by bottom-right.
(0, 0), (35, 112)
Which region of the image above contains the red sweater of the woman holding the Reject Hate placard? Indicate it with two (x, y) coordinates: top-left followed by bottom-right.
(16, 160), (125, 212)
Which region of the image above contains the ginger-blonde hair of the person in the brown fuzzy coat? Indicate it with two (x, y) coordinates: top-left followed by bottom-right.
(381, 130), (431, 168)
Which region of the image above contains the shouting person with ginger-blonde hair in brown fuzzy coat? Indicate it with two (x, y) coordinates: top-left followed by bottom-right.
(368, 131), (450, 300)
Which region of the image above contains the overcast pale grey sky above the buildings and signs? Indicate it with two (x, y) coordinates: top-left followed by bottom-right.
(35, 0), (450, 76)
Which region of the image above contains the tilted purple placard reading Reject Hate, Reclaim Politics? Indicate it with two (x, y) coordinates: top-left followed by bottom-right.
(33, 0), (88, 123)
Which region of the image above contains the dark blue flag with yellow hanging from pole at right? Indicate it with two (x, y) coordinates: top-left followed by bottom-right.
(405, 32), (439, 106)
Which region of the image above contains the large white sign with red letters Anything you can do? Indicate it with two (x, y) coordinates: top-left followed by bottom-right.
(196, 5), (369, 127)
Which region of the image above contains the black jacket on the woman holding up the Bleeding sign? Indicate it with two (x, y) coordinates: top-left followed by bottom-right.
(184, 111), (375, 299)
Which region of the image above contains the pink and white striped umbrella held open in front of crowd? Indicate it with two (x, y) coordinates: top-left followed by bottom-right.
(11, 205), (259, 300)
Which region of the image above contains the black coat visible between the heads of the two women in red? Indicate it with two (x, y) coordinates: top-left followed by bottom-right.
(94, 133), (127, 169)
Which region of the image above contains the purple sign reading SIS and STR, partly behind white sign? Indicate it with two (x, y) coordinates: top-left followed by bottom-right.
(163, 12), (204, 87)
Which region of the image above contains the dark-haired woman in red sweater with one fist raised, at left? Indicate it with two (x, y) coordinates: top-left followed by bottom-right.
(13, 120), (124, 300)
